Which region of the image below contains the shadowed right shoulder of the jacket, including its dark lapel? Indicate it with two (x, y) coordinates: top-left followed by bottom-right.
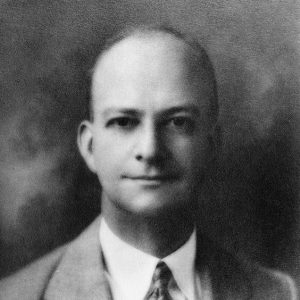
(196, 236), (298, 300)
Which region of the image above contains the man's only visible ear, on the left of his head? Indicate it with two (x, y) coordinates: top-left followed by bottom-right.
(77, 121), (96, 173)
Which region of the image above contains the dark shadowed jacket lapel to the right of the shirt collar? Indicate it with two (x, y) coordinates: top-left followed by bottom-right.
(196, 233), (252, 300)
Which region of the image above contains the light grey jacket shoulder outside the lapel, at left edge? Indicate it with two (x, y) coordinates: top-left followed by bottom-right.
(0, 246), (66, 300)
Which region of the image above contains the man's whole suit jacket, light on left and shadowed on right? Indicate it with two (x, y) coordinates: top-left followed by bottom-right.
(0, 218), (297, 300)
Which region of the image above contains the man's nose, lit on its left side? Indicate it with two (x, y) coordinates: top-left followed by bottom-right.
(135, 125), (164, 163)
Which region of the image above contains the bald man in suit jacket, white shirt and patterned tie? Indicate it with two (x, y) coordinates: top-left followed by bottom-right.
(0, 27), (296, 300)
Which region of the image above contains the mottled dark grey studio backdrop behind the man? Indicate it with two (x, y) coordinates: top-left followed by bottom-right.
(0, 0), (300, 284)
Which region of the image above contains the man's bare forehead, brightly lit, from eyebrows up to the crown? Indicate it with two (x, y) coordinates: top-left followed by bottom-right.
(91, 33), (211, 113)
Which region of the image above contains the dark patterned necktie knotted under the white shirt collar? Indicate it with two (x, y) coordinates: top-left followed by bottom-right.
(144, 261), (186, 300)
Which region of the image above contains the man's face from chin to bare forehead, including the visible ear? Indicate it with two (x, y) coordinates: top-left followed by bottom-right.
(79, 36), (212, 215)
